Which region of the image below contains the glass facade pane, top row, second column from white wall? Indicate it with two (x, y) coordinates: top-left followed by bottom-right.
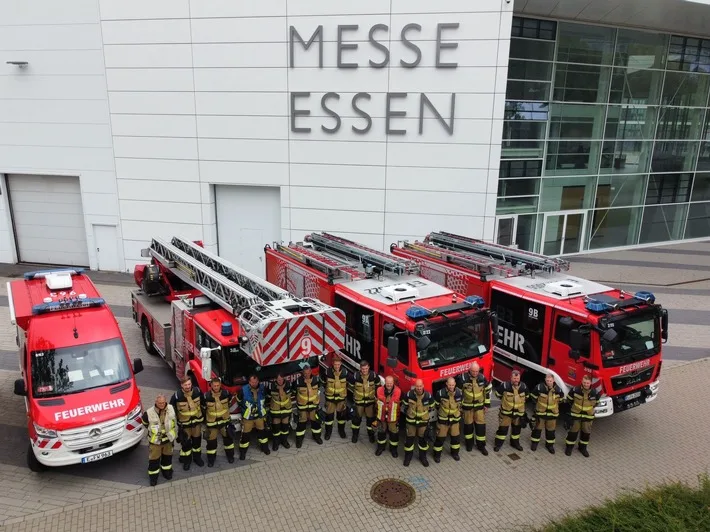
(557, 22), (614, 65)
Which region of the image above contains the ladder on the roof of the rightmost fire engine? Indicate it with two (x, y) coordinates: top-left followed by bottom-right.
(424, 231), (570, 275)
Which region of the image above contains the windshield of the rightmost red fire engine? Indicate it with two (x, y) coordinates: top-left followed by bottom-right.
(601, 313), (661, 367)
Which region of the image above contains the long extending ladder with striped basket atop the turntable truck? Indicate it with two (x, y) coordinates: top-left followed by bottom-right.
(144, 237), (345, 365)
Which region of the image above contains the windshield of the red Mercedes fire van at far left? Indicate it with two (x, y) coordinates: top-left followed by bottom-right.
(31, 338), (131, 397)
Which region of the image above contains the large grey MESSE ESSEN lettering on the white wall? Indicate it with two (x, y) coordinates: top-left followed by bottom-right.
(289, 22), (459, 135)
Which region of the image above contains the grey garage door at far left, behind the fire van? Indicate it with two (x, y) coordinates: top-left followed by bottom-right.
(7, 174), (89, 266)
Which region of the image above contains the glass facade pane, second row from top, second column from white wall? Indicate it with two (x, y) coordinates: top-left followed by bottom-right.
(552, 63), (611, 103)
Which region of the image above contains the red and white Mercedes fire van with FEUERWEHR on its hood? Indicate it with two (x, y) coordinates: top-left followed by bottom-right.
(7, 269), (143, 472)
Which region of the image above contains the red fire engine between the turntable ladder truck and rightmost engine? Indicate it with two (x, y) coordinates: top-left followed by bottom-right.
(264, 233), (495, 392)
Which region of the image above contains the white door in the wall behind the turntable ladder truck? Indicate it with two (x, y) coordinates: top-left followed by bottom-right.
(215, 185), (281, 277)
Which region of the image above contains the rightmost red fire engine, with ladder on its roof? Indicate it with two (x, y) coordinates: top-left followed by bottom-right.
(390, 232), (668, 417)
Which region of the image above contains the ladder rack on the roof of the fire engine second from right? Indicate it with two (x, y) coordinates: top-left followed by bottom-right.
(304, 233), (419, 275)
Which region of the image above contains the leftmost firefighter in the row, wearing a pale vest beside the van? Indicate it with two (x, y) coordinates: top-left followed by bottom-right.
(142, 394), (177, 486)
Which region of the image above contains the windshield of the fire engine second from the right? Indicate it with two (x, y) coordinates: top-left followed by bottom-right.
(418, 321), (489, 369)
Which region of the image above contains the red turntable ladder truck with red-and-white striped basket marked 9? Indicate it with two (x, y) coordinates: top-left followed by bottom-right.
(131, 237), (345, 420)
